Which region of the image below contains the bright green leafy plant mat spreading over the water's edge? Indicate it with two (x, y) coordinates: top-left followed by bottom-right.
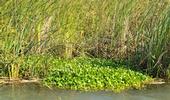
(44, 58), (151, 92)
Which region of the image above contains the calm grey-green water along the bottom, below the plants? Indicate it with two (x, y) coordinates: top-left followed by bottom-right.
(0, 84), (170, 100)
